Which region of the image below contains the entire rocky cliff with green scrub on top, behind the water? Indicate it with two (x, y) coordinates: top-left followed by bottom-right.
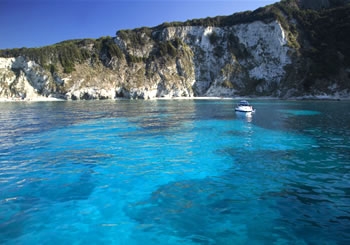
(0, 0), (350, 100)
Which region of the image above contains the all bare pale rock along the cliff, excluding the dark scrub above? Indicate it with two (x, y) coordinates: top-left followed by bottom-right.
(0, 21), (291, 99)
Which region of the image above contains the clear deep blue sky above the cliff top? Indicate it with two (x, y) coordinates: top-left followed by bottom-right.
(0, 0), (278, 49)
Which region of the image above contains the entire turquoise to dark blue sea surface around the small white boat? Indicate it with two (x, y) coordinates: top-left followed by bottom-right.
(0, 100), (350, 245)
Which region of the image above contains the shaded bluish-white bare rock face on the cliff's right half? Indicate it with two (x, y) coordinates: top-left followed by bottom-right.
(162, 21), (291, 96)
